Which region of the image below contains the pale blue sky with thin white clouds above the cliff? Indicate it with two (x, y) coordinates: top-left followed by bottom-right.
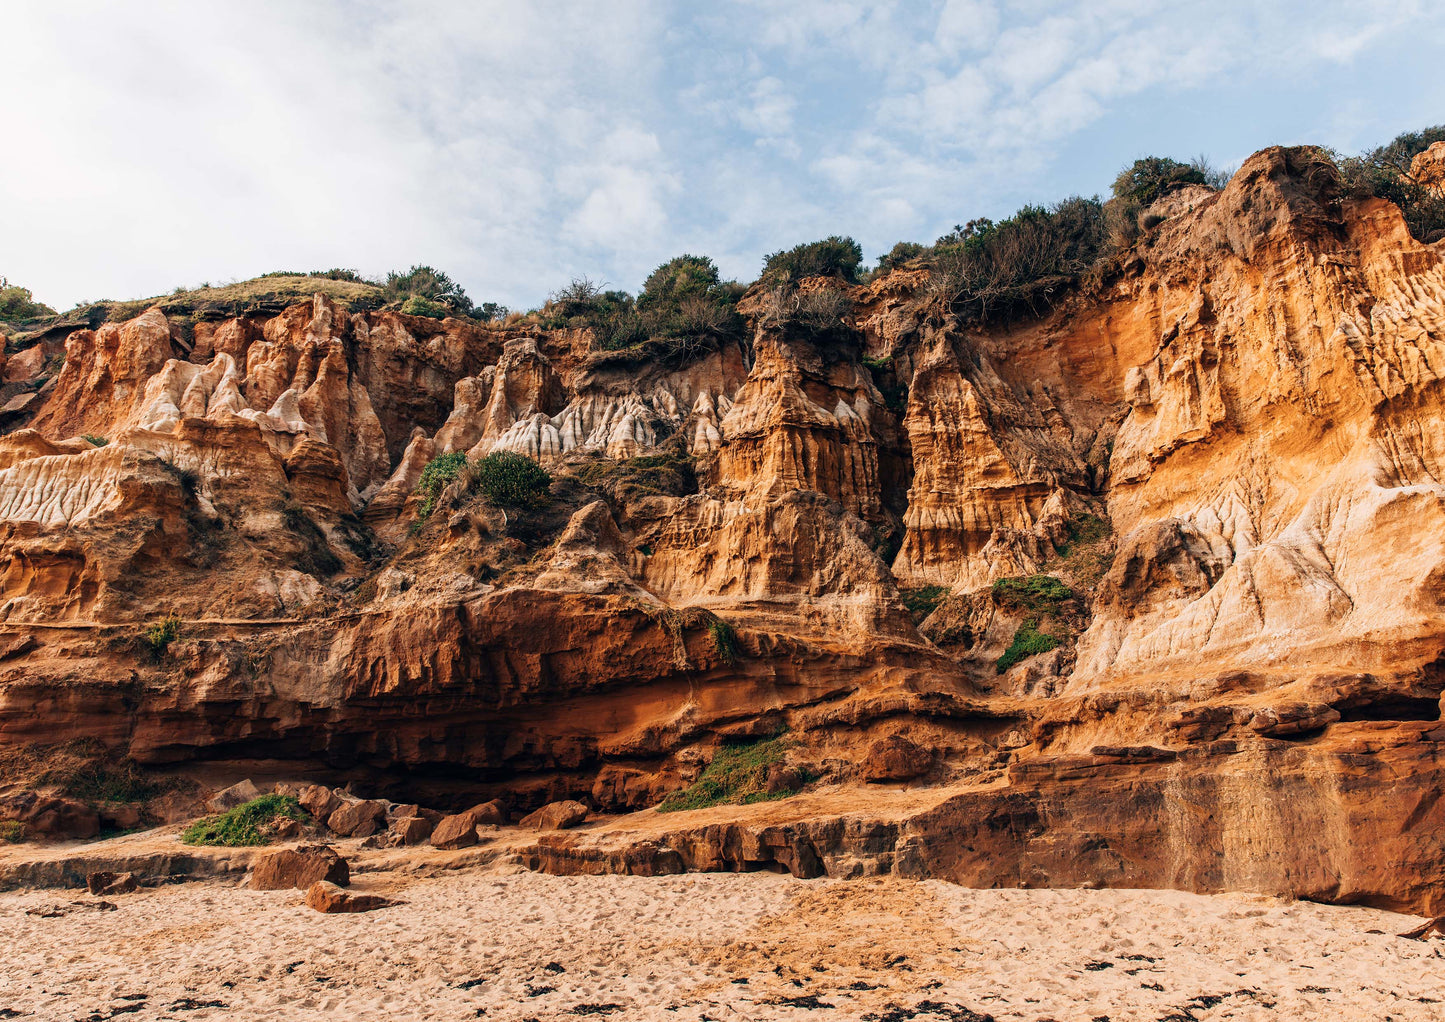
(0, 0), (1445, 309)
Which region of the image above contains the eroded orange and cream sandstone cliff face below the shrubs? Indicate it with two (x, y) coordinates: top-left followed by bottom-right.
(0, 149), (1445, 906)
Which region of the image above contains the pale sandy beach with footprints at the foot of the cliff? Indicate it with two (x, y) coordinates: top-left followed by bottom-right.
(0, 867), (1445, 1022)
